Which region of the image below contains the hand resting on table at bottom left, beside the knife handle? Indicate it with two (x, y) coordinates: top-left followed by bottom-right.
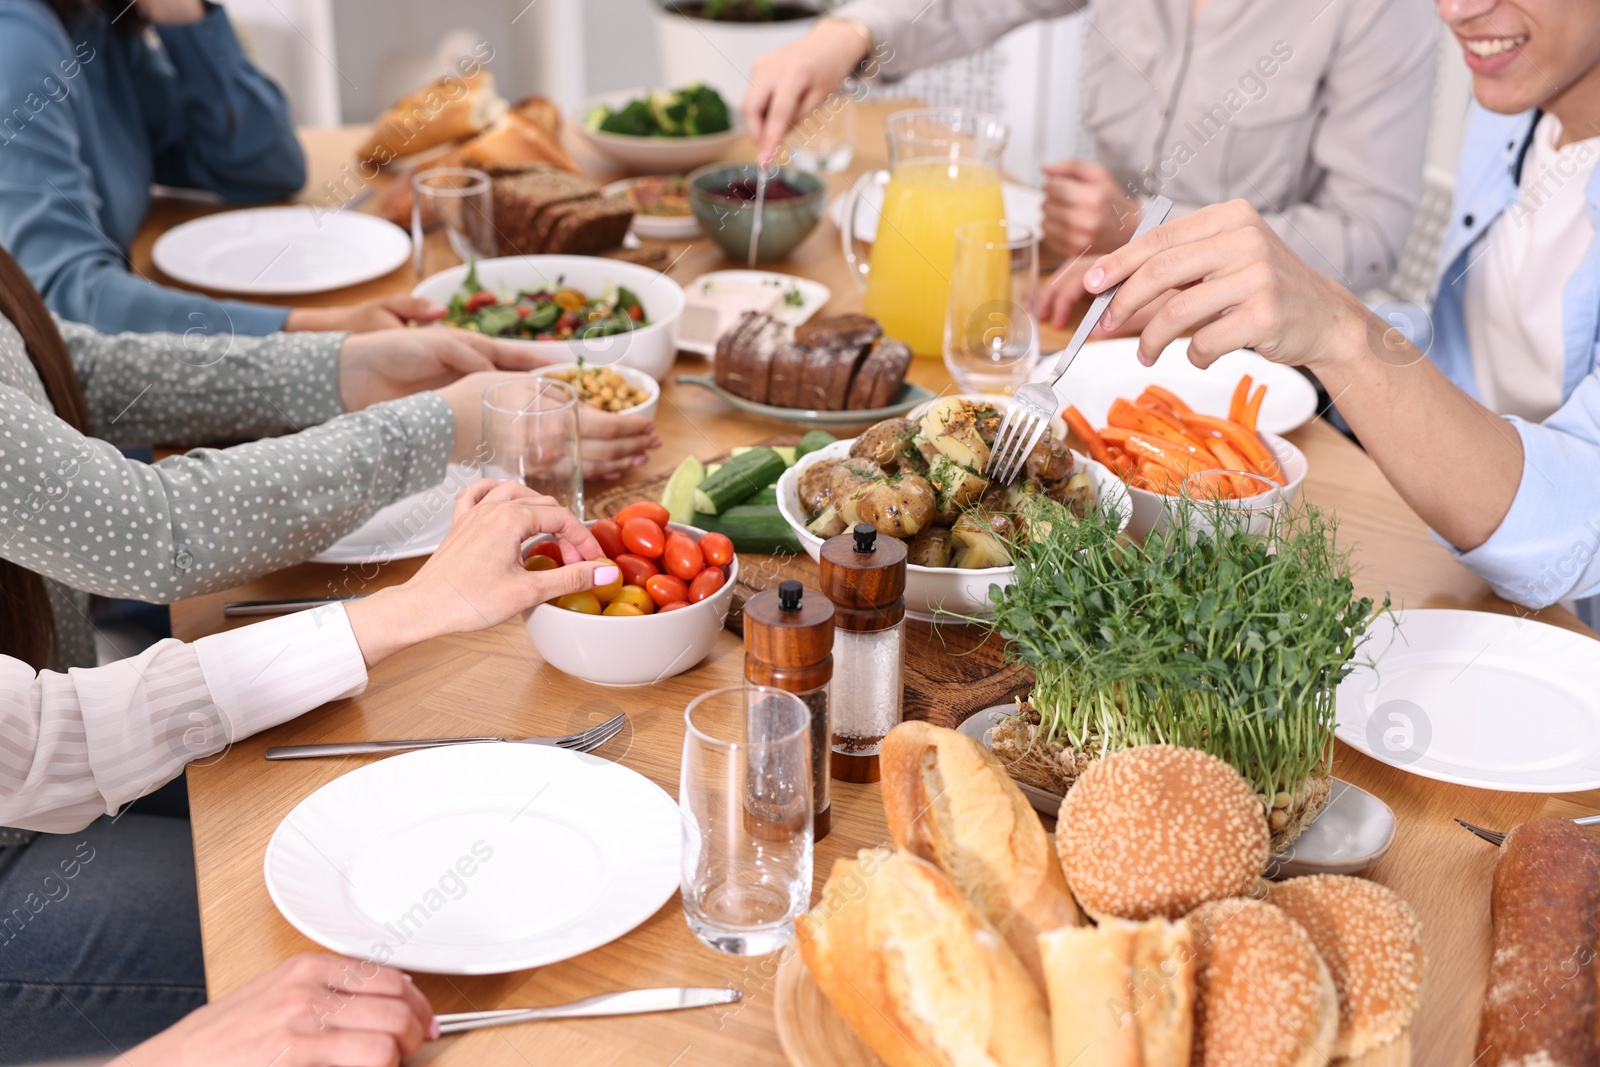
(112, 955), (438, 1067)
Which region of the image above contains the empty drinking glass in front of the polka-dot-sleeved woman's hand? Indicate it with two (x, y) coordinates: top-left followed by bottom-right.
(480, 374), (584, 518)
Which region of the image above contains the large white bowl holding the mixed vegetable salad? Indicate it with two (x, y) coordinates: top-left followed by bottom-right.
(411, 256), (685, 381)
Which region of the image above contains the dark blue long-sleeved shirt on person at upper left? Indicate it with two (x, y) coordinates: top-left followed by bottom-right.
(0, 0), (306, 334)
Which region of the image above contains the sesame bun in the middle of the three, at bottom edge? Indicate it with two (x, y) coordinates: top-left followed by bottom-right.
(1189, 897), (1339, 1067)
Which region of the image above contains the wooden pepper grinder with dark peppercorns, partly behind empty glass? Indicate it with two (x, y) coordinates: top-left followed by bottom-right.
(744, 581), (834, 841)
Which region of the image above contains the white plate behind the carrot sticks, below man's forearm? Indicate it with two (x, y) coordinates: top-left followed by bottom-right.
(1046, 338), (1317, 434)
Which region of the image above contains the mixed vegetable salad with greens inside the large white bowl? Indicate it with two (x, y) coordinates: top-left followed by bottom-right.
(445, 264), (650, 341)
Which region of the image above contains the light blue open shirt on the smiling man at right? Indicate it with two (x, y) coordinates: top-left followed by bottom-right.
(1427, 104), (1600, 621)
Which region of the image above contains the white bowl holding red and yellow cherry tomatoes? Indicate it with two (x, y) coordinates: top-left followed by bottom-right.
(523, 520), (739, 686)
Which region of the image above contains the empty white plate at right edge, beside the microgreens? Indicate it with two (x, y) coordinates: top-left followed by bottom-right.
(1338, 609), (1600, 793)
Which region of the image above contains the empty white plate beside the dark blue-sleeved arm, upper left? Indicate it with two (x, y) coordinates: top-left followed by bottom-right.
(150, 205), (411, 296)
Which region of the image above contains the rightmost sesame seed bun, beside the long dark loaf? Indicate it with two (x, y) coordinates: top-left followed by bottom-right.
(1267, 875), (1422, 1056)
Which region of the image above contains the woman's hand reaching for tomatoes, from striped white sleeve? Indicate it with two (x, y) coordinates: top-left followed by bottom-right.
(346, 482), (618, 667)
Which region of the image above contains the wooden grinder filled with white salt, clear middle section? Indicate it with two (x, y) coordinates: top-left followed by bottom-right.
(821, 523), (906, 782)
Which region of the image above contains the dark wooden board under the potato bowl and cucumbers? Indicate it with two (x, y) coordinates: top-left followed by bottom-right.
(584, 435), (1034, 728)
